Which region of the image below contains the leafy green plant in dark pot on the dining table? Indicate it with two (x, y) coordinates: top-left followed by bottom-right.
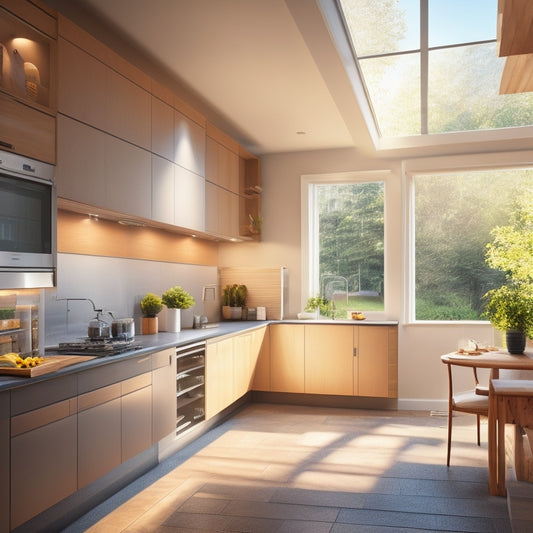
(484, 281), (533, 354)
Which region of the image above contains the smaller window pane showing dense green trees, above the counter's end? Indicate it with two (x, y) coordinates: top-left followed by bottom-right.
(307, 180), (385, 316)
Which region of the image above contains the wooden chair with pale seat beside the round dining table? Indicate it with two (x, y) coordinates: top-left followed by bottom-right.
(446, 364), (489, 466)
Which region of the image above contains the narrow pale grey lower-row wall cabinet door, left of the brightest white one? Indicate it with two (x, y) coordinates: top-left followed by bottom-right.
(151, 154), (176, 224)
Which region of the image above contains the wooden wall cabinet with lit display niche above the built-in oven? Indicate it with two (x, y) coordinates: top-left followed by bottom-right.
(0, 0), (57, 163)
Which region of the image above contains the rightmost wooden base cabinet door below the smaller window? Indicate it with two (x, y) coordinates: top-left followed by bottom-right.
(356, 326), (389, 398)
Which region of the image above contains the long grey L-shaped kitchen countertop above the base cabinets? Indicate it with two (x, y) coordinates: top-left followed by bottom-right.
(0, 319), (398, 391)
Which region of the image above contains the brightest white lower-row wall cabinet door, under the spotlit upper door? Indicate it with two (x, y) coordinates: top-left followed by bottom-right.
(174, 165), (205, 231)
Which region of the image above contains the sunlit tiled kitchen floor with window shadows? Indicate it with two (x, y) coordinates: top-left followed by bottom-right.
(65, 404), (511, 533)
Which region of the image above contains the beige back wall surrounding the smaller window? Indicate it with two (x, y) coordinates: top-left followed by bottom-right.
(219, 145), (494, 410)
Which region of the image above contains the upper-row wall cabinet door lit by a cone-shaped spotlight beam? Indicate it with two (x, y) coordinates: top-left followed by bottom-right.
(174, 111), (206, 177)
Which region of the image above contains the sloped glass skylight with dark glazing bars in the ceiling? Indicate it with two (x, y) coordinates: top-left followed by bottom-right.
(337, 0), (533, 138)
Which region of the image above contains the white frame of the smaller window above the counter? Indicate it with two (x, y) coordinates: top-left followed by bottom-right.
(300, 170), (392, 320)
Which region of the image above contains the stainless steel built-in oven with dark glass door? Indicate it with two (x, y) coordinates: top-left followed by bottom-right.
(0, 150), (57, 289)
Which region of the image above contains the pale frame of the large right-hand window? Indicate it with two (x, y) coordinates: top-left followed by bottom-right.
(402, 151), (533, 325)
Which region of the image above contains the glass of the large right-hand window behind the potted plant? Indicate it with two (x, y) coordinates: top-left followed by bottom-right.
(411, 168), (533, 320)
